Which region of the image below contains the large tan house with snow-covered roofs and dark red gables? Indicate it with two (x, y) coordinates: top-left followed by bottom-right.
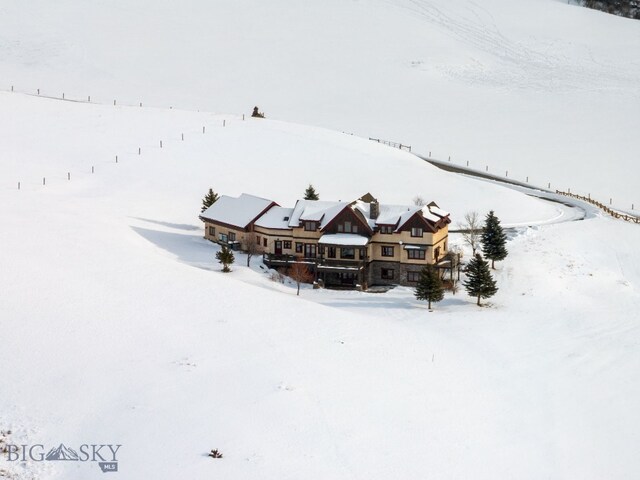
(200, 193), (451, 288)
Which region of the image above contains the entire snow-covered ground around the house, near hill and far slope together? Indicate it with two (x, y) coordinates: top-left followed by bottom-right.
(0, 0), (640, 480)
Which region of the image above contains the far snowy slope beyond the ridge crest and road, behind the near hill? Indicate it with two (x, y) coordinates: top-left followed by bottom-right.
(0, 0), (640, 209)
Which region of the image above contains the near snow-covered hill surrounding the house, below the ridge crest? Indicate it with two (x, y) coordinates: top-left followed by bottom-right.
(0, 88), (640, 480)
